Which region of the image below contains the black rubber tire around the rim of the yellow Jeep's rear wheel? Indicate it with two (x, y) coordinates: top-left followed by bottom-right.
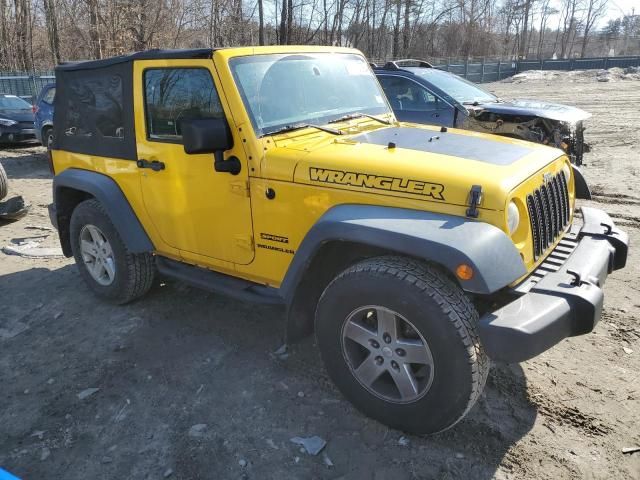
(70, 199), (155, 304)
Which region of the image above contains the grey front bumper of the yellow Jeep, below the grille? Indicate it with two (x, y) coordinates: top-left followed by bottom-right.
(478, 207), (629, 363)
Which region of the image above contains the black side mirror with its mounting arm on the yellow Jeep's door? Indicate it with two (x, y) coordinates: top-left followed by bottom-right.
(181, 117), (241, 175)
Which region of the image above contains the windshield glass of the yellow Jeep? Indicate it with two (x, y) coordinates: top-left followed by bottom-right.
(230, 53), (391, 135)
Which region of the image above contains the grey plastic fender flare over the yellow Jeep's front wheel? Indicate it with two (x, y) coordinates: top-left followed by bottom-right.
(280, 204), (526, 303)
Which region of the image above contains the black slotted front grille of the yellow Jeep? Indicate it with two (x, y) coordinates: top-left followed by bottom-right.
(527, 172), (571, 260)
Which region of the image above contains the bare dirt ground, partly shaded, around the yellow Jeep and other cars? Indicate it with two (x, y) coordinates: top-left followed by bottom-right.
(0, 76), (640, 480)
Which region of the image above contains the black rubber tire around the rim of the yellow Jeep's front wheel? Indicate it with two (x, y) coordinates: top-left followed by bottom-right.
(315, 256), (490, 433)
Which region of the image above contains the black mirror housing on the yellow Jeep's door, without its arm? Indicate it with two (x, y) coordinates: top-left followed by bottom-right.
(181, 118), (233, 154)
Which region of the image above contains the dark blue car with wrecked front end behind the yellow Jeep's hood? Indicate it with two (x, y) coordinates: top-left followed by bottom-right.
(372, 60), (591, 165)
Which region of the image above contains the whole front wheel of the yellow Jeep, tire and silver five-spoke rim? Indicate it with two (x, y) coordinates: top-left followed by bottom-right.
(316, 257), (489, 433)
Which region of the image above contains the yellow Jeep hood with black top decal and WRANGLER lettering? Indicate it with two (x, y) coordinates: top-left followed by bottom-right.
(265, 126), (563, 210)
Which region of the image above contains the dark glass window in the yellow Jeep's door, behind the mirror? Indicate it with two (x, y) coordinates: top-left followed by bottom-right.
(144, 68), (223, 143)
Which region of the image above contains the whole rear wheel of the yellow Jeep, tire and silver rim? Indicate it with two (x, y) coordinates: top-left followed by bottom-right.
(70, 200), (155, 304)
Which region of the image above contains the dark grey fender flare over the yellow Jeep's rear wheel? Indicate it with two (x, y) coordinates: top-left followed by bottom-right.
(53, 168), (154, 256)
